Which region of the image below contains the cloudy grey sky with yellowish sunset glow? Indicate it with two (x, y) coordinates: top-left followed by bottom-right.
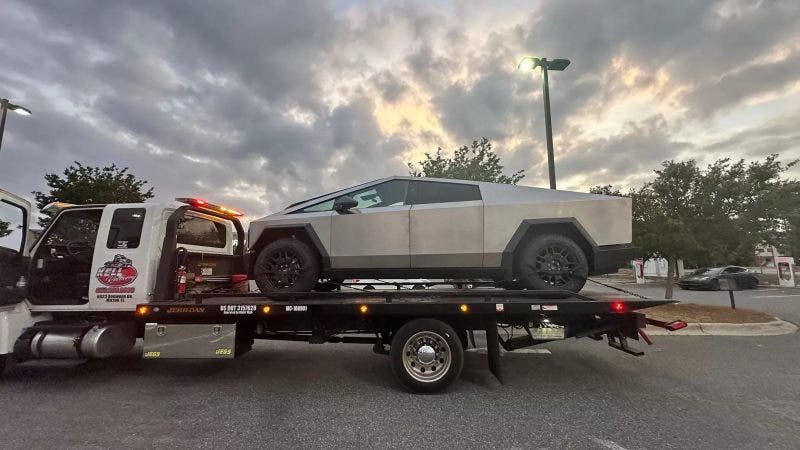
(0, 0), (800, 216)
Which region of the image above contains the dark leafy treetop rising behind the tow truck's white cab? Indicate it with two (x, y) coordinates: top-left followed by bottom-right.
(33, 161), (153, 227)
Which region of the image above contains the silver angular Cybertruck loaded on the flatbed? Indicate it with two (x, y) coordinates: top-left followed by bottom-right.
(248, 176), (634, 292)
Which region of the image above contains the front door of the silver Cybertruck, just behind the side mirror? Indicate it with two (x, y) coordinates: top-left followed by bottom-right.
(331, 180), (411, 269)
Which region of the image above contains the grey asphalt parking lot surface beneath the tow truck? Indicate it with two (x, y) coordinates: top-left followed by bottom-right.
(0, 282), (800, 449)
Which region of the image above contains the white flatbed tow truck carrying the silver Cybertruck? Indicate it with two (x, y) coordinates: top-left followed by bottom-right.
(0, 191), (685, 393)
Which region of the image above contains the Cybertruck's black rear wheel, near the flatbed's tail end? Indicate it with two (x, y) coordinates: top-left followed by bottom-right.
(518, 234), (589, 292)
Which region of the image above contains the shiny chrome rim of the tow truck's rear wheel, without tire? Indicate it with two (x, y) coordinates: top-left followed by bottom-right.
(403, 331), (453, 383)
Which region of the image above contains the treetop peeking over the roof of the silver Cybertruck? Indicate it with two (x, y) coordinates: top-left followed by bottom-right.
(407, 138), (525, 184)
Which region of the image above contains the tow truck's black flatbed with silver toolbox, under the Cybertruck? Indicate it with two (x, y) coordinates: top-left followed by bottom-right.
(137, 288), (672, 392)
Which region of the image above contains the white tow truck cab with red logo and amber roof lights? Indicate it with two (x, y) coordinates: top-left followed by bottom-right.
(0, 190), (247, 369)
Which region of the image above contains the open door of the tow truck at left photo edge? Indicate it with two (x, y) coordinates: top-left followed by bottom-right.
(0, 189), (31, 306)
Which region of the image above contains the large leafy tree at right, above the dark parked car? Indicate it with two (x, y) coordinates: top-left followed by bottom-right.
(592, 155), (800, 298)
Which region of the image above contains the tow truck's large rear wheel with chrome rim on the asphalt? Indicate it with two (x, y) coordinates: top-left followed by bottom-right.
(389, 319), (464, 394)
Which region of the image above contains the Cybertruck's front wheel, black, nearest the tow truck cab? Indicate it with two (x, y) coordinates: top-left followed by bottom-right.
(253, 238), (319, 294)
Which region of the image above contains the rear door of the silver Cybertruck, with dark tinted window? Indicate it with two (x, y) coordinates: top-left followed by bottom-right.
(408, 181), (483, 268)
